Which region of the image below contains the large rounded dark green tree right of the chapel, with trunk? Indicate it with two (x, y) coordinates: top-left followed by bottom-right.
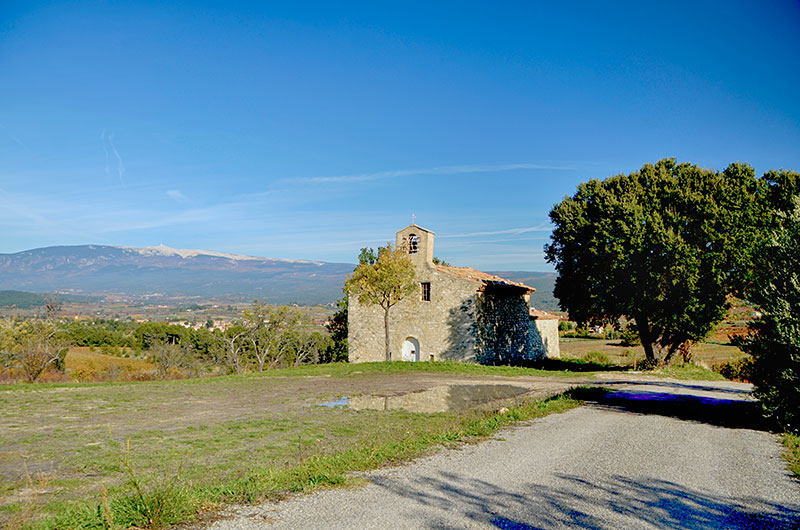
(545, 159), (770, 363)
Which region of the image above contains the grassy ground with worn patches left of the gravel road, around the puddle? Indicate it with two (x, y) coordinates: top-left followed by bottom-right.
(0, 363), (604, 529)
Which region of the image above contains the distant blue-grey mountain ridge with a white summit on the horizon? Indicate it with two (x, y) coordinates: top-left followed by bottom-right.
(0, 245), (558, 310)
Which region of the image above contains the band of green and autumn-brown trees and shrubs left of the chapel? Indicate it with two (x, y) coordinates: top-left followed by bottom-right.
(0, 300), (347, 382)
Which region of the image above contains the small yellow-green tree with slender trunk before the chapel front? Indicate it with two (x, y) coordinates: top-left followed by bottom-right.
(344, 243), (417, 361)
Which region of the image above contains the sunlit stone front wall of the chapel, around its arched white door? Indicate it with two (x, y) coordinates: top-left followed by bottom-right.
(348, 264), (479, 363)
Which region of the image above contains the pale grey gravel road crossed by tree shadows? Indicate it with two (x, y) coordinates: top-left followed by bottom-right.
(208, 380), (800, 530)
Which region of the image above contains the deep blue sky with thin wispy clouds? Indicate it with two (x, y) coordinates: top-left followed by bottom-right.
(0, 0), (800, 270)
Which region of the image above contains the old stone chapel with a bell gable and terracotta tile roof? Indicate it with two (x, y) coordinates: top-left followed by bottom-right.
(347, 223), (559, 364)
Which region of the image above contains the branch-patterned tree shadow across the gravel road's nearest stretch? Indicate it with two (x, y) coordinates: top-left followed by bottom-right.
(373, 473), (800, 530)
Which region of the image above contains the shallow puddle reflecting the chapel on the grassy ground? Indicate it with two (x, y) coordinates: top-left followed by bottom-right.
(345, 385), (529, 412)
